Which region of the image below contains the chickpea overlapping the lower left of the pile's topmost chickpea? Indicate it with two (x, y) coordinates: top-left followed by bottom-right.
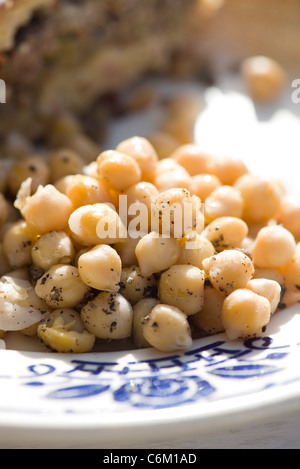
(97, 150), (142, 191)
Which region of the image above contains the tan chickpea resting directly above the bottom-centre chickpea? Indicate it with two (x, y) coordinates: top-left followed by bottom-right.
(158, 265), (204, 316)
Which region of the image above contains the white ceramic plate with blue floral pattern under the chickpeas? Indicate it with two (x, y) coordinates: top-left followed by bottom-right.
(0, 76), (300, 448)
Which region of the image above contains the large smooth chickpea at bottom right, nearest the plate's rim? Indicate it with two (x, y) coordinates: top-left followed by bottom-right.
(221, 288), (271, 340)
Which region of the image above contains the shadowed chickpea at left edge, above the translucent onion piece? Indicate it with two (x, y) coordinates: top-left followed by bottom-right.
(2, 219), (36, 269)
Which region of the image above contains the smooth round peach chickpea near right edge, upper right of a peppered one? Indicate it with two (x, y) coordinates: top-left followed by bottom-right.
(251, 225), (296, 269)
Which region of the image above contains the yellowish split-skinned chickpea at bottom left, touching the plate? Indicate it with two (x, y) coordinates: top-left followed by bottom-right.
(37, 309), (95, 353)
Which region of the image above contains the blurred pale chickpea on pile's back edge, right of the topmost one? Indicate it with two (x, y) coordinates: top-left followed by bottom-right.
(171, 143), (214, 176)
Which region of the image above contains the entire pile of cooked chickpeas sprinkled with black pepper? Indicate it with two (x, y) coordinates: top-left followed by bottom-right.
(0, 132), (300, 353)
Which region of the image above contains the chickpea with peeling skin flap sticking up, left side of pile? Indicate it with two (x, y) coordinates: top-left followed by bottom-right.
(22, 184), (72, 235)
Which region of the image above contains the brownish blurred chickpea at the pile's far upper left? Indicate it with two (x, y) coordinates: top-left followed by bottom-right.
(7, 155), (50, 195)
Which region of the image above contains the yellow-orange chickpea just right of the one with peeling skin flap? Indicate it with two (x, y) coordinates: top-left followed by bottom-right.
(61, 174), (112, 210)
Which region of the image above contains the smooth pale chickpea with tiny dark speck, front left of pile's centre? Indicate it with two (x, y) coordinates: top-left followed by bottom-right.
(78, 244), (122, 291)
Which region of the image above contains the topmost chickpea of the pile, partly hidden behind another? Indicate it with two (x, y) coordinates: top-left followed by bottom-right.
(116, 137), (158, 182)
